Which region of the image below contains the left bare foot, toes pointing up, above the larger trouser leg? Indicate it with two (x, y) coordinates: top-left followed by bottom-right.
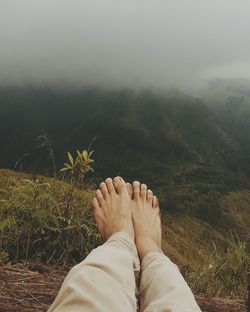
(92, 177), (134, 240)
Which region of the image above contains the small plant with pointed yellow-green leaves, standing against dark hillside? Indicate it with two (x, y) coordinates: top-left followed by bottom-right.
(60, 150), (94, 181)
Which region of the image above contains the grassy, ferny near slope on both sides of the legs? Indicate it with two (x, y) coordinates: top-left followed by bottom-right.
(0, 169), (250, 299)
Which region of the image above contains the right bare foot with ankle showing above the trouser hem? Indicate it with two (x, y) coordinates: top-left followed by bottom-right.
(130, 181), (161, 261)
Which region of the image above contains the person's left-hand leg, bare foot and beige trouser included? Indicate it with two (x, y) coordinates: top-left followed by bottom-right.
(49, 178), (139, 312)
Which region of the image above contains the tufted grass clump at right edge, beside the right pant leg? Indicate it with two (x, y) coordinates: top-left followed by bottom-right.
(186, 236), (250, 299)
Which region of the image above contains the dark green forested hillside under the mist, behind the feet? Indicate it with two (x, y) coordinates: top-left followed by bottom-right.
(0, 81), (250, 235)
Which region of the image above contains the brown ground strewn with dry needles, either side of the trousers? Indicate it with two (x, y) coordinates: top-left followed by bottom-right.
(0, 264), (246, 312)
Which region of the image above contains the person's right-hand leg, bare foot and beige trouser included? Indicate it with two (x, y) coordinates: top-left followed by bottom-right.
(132, 182), (201, 312)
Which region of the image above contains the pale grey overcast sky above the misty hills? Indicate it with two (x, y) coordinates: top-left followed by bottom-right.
(0, 0), (250, 89)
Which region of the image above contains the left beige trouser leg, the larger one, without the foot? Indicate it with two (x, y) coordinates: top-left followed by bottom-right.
(48, 232), (140, 312)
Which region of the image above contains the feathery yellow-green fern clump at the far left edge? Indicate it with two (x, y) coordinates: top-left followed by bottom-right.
(0, 179), (58, 260)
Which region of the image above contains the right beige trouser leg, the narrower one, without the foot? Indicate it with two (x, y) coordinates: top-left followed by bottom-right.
(139, 252), (201, 312)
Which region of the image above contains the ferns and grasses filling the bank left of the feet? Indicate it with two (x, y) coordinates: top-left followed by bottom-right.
(0, 178), (99, 264)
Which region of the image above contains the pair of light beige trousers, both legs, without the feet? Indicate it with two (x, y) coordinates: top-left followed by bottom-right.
(49, 232), (201, 312)
